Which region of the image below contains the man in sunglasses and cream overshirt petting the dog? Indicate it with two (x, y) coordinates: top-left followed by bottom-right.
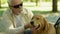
(3, 0), (33, 34)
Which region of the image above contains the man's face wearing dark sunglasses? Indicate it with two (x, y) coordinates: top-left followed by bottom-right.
(9, 0), (23, 15)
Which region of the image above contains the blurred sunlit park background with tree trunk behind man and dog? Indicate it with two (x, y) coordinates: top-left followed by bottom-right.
(0, 0), (60, 24)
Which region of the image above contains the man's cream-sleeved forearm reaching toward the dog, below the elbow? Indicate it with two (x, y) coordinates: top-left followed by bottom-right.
(6, 26), (24, 34)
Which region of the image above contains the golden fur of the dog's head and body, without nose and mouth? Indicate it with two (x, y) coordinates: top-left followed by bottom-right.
(31, 15), (56, 34)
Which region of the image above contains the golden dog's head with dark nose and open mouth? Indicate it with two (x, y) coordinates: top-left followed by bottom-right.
(30, 15), (47, 29)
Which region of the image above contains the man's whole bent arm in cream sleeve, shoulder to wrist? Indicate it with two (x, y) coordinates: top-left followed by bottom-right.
(2, 10), (25, 34)
